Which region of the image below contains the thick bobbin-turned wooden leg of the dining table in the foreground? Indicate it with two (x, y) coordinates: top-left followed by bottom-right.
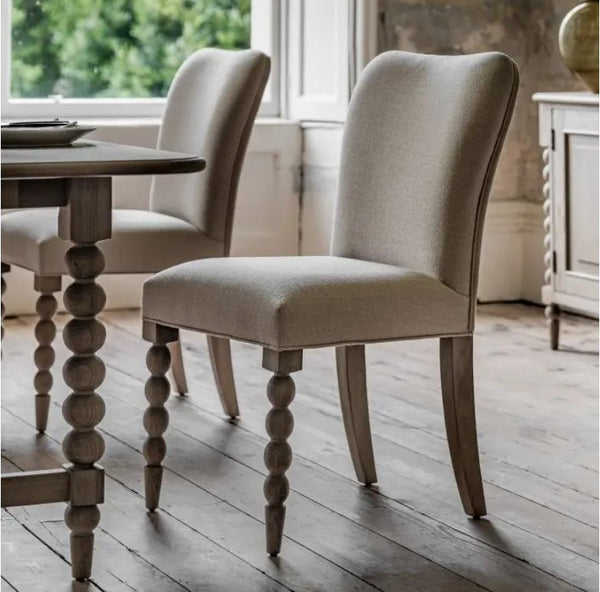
(58, 177), (112, 580)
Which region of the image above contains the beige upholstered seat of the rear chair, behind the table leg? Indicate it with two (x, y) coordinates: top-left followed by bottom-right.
(1, 208), (223, 275)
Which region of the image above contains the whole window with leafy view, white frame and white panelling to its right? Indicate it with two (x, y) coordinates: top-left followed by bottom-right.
(1, 0), (377, 122)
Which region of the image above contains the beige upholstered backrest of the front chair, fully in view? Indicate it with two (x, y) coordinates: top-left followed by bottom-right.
(331, 51), (519, 320)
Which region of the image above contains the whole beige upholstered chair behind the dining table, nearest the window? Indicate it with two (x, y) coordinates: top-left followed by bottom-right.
(1, 49), (270, 432)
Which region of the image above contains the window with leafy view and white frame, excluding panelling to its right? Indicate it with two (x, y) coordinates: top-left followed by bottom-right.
(2, 0), (279, 117)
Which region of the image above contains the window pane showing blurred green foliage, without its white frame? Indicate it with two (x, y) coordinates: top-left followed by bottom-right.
(11, 0), (250, 98)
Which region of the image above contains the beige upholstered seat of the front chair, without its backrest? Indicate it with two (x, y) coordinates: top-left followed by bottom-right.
(143, 257), (469, 350)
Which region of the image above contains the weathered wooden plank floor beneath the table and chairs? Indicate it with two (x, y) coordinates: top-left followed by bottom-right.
(2, 305), (598, 592)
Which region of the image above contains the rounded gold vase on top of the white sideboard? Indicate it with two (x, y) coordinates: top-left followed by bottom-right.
(558, 0), (598, 93)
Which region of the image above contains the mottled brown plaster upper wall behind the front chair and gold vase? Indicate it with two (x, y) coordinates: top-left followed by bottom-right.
(380, 0), (583, 202)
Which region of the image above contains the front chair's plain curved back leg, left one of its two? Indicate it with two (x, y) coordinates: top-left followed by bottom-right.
(335, 345), (377, 485)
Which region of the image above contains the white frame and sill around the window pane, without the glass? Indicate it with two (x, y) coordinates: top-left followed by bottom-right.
(0, 0), (284, 119)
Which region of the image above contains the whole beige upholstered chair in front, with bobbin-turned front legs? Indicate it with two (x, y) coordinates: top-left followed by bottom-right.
(143, 52), (518, 555)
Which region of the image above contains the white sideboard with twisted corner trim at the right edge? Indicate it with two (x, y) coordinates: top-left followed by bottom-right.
(533, 92), (599, 349)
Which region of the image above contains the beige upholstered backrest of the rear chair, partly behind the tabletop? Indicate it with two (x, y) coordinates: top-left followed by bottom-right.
(150, 48), (271, 255)
